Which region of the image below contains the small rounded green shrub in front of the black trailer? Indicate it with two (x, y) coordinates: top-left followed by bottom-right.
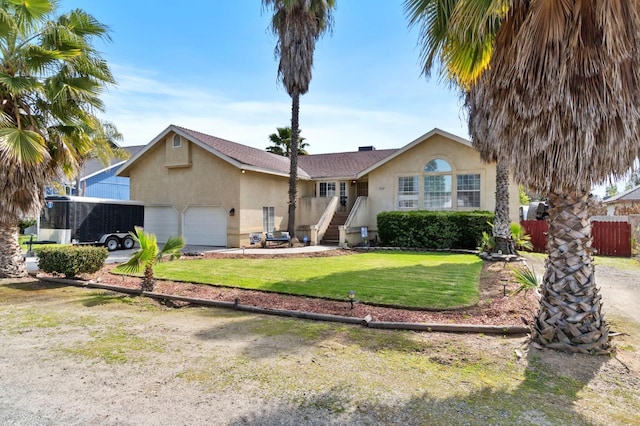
(36, 246), (109, 278)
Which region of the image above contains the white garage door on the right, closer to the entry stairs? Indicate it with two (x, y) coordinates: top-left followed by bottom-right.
(182, 206), (227, 247)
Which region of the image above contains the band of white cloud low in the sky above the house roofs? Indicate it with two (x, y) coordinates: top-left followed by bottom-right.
(104, 66), (466, 153)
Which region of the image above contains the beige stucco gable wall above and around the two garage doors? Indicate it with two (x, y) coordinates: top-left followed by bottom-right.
(129, 133), (241, 245)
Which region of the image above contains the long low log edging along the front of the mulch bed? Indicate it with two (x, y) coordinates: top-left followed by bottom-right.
(35, 275), (530, 335)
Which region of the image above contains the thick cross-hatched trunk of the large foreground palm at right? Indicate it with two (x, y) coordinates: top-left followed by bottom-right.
(532, 190), (611, 354)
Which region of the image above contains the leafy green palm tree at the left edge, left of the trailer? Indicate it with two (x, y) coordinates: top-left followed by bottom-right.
(0, 0), (114, 277)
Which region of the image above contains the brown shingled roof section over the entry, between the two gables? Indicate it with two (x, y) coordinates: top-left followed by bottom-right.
(298, 149), (397, 179)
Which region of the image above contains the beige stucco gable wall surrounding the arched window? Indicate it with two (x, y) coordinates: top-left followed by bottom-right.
(368, 134), (518, 229)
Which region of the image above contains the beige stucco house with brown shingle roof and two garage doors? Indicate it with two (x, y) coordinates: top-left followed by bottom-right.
(117, 125), (518, 247)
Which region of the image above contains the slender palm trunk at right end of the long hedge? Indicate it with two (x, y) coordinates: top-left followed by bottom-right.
(493, 160), (516, 254)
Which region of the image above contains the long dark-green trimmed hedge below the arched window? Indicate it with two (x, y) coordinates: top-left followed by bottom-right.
(377, 211), (494, 249)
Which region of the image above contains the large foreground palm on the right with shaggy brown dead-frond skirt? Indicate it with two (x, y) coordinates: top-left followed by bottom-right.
(408, 0), (640, 353)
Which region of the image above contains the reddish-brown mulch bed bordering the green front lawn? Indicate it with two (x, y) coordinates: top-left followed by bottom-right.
(76, 250), (538, 326)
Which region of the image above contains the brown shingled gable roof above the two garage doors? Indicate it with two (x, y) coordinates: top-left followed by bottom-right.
(116, 125), (309, 180)
